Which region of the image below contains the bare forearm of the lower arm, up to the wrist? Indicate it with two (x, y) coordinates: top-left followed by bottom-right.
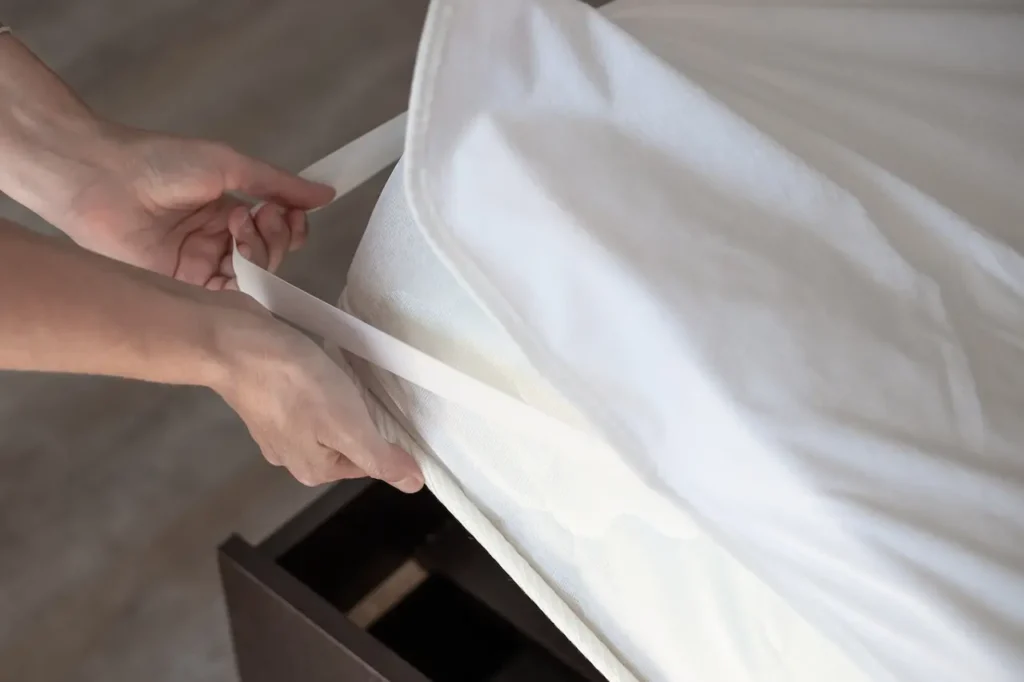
(0, 220), (231, 388)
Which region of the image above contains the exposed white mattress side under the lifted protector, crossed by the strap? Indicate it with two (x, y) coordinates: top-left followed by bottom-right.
(341, 160), (863, 682)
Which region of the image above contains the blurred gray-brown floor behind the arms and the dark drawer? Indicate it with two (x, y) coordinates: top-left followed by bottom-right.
(0, 0), (426, 682)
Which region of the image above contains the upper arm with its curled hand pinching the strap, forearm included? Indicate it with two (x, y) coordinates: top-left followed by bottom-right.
(0, 37), (333, 290)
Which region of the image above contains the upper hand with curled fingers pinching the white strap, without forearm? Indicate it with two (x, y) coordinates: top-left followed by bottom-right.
(56, 123), (334, 290)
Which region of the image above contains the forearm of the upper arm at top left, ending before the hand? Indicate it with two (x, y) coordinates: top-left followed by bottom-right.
(0, 34), (116, 229)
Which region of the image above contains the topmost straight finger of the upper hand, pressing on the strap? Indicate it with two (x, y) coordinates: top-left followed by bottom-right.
(217, 147), (334, 210)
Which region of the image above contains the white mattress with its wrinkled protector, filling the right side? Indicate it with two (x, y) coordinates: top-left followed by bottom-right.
(343, 0), (1024, 682)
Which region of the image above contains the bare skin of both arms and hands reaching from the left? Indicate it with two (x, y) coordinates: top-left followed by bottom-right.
(0, 35), (423, 492)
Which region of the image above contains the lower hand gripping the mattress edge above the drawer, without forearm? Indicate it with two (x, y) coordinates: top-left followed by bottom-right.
(213, 292), (423, 493)
